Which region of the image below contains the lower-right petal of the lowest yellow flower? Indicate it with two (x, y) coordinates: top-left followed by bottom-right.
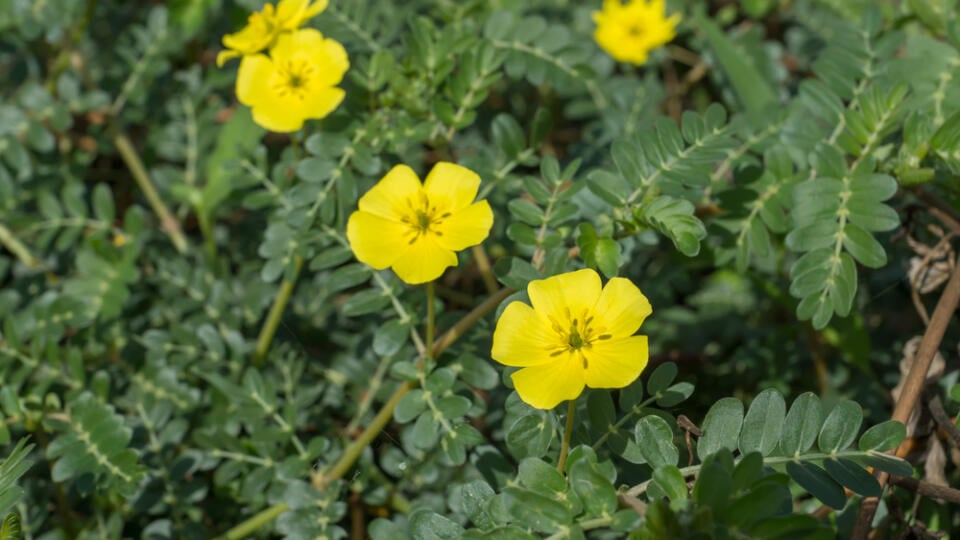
(583, 336), (649, 388)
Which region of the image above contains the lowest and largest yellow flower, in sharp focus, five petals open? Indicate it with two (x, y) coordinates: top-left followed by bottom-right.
(491, 269), (652, 409)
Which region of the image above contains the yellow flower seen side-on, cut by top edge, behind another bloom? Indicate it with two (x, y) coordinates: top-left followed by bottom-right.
(217, 0), (327, 67)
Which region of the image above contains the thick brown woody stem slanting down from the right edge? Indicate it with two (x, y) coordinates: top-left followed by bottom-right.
(851, 265), (960, 540)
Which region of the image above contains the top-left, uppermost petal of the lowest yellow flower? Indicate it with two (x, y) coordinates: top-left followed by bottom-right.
(527, 268), (601, 324)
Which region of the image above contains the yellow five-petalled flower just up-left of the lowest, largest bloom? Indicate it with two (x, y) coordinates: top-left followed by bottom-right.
(347, 162), (493, 284)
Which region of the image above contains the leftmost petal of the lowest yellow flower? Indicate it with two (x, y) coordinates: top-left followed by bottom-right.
(490, 302), (563, 367)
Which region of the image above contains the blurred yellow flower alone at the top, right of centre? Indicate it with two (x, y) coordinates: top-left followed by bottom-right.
(593, 0), (680, 66)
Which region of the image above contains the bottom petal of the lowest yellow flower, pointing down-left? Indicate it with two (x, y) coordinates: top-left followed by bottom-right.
(511, 354), (584, 409)
